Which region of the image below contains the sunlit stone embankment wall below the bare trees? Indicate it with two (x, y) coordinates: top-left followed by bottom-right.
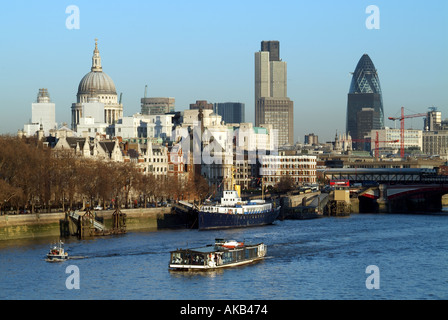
(0, 207), (171, 241)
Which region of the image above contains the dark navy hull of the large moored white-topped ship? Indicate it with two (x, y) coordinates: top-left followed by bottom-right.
(198, 207), (280, 230)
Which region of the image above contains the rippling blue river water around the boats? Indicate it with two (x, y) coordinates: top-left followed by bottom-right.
(0, 214), (448, 300)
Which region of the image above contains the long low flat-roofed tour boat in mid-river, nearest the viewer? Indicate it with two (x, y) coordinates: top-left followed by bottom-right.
(169, 239), (267, 271)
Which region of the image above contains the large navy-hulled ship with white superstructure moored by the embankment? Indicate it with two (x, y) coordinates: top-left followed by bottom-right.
(198, 190), (280, 230)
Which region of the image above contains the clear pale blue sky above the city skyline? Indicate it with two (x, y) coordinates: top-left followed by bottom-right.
(0, 0), (448, 142)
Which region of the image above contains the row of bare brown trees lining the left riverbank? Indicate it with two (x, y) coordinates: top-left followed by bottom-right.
(0, 136), (209, 212)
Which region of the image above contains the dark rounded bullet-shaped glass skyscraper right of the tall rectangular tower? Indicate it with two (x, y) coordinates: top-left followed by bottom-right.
(346, 54), (384, 150)
